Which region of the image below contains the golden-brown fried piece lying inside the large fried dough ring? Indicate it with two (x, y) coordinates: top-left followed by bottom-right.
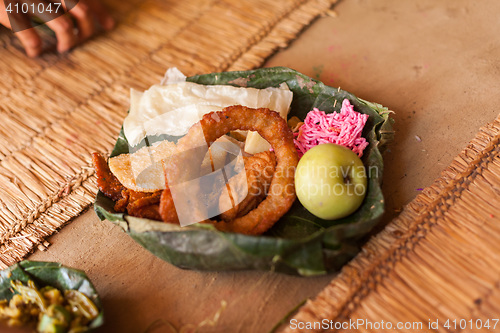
(219, 151), (276, 222)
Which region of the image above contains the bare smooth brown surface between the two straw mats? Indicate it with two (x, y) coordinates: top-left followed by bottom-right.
(21, 0), (500, 333)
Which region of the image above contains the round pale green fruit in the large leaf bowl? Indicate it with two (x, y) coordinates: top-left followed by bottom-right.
(295, 143), (367, 220)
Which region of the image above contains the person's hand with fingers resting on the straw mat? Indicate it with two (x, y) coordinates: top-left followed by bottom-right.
(0, 0), (115, 57)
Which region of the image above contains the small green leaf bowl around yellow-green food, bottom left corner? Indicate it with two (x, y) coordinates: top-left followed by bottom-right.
(0, 260), (104, 331)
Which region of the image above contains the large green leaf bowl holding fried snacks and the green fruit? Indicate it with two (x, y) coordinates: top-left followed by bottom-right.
(94, 67), (394, 276)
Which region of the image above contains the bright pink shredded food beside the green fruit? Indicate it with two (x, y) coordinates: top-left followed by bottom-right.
(293, 99), (368, 158)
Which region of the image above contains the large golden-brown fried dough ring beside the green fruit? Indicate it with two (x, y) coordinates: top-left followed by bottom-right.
(167, 105), (298, 235)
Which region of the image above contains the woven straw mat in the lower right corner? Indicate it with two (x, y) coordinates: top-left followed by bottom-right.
(282, 115), (500, 333)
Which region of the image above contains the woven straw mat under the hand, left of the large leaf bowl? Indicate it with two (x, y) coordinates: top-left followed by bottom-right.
(0, 0), (336, 268)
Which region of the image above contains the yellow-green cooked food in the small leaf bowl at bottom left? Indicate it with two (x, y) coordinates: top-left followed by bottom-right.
(0, 281), (99, 333)
